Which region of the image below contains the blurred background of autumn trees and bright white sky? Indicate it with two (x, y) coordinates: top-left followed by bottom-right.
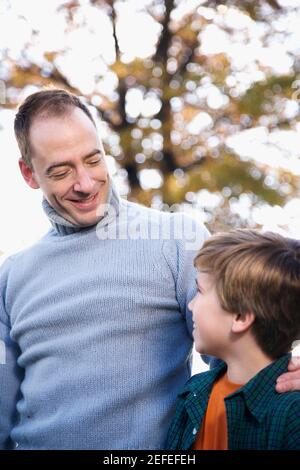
(0, 0), (300, 368)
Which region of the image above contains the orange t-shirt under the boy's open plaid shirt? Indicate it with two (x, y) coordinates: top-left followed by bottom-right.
(192, 374), (242, 450)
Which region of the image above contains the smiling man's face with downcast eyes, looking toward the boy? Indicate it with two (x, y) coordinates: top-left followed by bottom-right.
(19, 108), (109, 226)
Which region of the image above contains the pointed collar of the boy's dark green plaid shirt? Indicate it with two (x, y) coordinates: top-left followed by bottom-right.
(179, 354), (291, 427)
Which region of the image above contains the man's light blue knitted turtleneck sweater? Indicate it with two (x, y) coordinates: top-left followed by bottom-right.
(0, 184), (208, 449)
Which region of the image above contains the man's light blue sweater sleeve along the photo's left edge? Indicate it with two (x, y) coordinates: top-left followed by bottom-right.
(0, 259), (21, 450)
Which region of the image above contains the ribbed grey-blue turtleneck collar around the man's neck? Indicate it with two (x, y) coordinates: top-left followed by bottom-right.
(42, 178), (121, 235)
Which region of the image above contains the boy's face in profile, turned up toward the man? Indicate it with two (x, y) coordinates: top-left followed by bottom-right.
(189, 273), (233, 358)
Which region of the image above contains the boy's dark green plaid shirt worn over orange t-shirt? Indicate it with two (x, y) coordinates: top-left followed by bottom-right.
(165, 354), (300, 450)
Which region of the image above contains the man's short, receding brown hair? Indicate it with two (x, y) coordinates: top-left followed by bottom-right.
(14, 88), (95, 167)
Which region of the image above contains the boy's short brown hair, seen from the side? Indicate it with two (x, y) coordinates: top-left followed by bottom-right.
(194, 229), (300, 359)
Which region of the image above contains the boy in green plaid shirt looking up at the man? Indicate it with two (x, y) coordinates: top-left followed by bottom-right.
(166, 230), (300, 450)
